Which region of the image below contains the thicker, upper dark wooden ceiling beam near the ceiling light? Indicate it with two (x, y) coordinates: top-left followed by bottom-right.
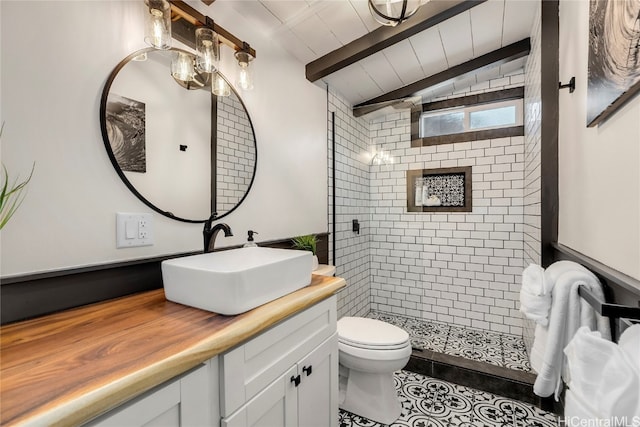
(305, 0), (487, 82)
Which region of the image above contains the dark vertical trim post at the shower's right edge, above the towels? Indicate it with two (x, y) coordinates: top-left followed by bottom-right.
(540, 0), (560, 267)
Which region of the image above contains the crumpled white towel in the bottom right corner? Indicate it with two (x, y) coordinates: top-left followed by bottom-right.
(564, 325), (640, 421)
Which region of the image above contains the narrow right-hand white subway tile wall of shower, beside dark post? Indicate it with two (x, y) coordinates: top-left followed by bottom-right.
(522, 6), (542, 354)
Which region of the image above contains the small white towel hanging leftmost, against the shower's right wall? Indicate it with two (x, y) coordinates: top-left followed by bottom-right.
(520, 264), (551, 326)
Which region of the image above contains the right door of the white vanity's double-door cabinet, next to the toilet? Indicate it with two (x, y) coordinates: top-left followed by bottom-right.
(298, 333), (338, 427)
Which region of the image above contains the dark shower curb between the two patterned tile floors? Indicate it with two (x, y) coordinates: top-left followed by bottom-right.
(404, 349), (564, 414)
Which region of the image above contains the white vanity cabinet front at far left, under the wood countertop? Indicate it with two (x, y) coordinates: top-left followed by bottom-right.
(85, 357), (220, 427)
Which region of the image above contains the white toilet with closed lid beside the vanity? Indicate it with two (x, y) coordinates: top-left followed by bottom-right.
(313, 265), (411, 424)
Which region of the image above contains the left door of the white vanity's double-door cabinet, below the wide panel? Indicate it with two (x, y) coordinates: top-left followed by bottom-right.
(221, 366), (298, 427)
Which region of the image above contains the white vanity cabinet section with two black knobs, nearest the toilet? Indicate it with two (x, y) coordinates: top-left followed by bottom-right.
(220, 296), (338, 427)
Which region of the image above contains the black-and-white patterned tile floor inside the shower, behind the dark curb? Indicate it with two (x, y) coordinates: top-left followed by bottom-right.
(368, 311), (531, 372)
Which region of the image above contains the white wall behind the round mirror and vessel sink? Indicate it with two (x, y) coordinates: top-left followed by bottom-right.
(0, 1), (327, 276)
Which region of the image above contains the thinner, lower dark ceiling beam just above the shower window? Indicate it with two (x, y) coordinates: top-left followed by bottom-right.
(353, 37), (531, 117)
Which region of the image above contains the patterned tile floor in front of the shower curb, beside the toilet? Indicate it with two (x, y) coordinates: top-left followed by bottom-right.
(339, 371), (558, 427)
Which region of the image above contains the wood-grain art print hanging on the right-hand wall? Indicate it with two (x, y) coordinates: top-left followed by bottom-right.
(587, 0), (640, 127)
